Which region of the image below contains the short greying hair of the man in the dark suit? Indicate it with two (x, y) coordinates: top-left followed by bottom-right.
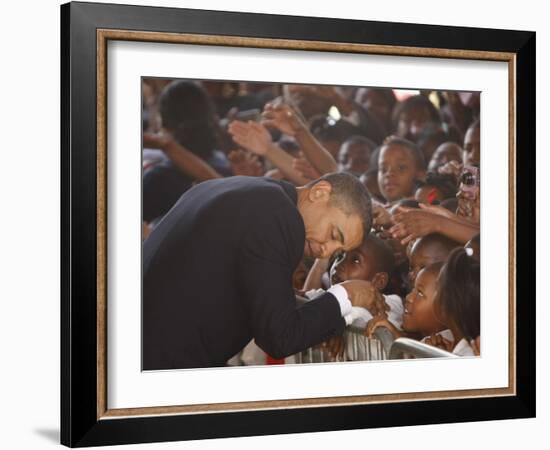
(305, 172), (372, 236)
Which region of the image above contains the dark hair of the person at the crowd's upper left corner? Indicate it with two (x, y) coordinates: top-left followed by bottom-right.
(159, 81), (220, 158)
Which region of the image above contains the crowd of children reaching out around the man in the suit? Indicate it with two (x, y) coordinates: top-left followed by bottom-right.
(142, 78), (480, 364)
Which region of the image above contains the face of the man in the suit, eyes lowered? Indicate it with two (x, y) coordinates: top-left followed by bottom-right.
(298, 181), (363, 258)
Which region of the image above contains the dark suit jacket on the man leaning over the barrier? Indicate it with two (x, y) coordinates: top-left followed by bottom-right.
(142, 177), (345, 370)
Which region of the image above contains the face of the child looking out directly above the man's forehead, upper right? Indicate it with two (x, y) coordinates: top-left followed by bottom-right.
(378, 145), (418, 202)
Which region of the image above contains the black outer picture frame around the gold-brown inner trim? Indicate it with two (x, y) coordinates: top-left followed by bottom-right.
(60, 2), (536, 447)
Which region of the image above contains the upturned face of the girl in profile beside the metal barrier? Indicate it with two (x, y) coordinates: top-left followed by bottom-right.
(403, 269), (444, 336)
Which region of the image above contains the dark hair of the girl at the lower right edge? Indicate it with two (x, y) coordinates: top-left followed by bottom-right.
(435, 247), (480, 342)
